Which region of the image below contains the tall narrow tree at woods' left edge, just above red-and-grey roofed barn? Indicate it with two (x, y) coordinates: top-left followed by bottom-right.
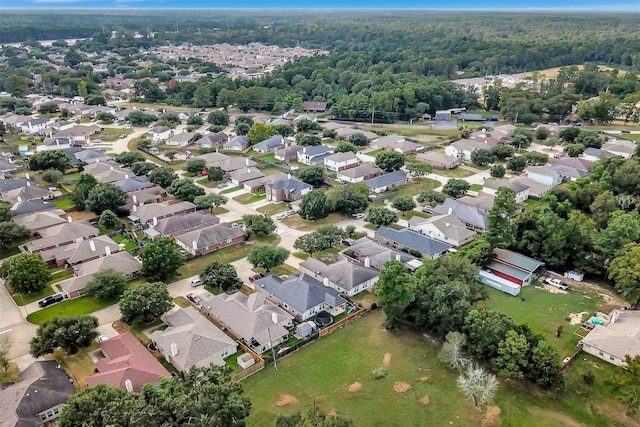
(486, 187), (518, 247)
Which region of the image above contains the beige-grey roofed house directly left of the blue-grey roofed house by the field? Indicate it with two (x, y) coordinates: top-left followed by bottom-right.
(202, 292), (293, 354)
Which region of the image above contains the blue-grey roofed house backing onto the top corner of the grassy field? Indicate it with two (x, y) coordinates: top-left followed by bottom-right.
(254, 273), (347, 321)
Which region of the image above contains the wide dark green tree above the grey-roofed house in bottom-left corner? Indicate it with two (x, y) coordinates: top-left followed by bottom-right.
(29, 316), (98, 358)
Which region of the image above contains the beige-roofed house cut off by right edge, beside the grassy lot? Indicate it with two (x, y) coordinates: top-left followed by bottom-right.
(582, 310), (640, 366)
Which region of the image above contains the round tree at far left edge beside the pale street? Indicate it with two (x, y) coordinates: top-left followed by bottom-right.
(0, 253), (51, 294)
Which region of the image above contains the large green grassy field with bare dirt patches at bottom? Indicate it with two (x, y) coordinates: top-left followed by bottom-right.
(242, 310), (640, 427)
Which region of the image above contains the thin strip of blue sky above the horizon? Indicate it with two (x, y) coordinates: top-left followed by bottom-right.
(0, 0), (640, 12)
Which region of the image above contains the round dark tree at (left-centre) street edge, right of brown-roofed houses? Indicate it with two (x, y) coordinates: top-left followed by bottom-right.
(140, 237), (184, 280)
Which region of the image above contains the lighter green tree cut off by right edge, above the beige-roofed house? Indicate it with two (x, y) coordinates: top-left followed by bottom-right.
(607, 243), (640, 306)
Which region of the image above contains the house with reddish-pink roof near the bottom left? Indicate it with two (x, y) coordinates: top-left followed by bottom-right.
(87, 332), (171, 392)
